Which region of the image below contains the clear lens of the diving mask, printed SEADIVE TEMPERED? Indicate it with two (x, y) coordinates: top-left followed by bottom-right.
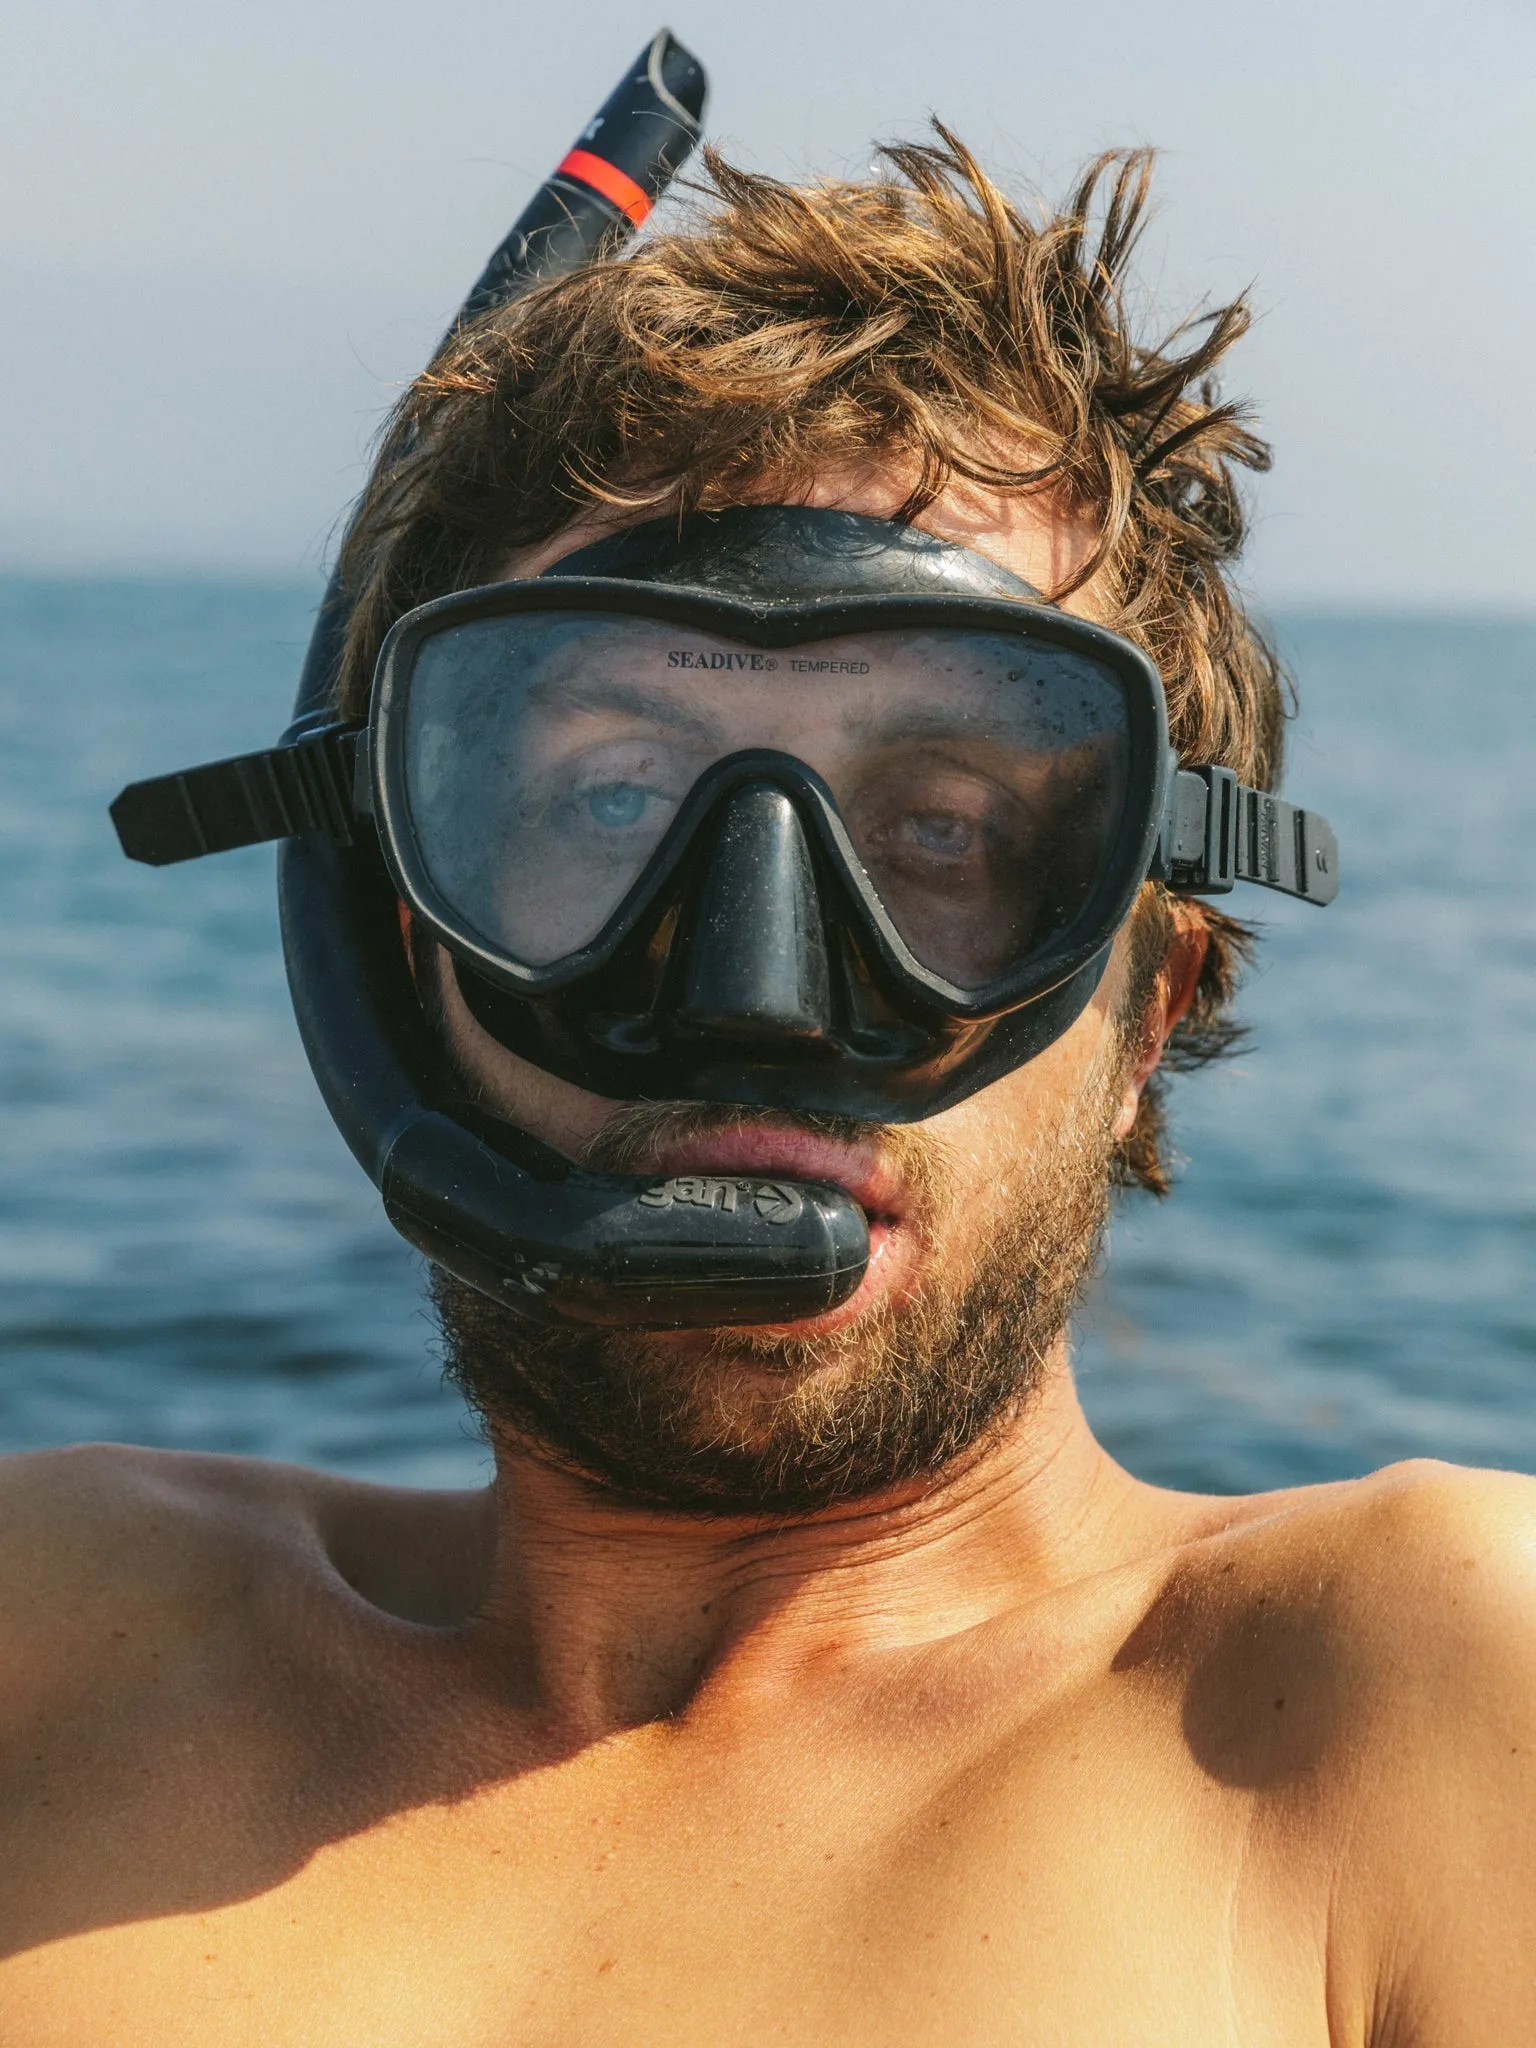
(403, 612), (1128, 989)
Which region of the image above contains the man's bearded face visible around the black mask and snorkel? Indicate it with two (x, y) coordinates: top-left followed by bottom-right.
(418, 481), (1147, 1513)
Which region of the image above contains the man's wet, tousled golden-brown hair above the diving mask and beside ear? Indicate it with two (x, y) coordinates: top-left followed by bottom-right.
(338, 123), (1288, 1194)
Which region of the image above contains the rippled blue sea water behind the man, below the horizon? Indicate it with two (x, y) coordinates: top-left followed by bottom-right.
(0, 580), (1536, 1491)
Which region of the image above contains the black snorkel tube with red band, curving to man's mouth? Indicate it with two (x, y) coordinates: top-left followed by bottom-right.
(270, 29), (868, 1329)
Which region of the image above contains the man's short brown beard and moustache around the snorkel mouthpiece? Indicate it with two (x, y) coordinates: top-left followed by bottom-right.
(432, 1044), (1124, 1516)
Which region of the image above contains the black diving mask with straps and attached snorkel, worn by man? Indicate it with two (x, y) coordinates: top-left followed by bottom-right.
(113, 44), (1337, 1329)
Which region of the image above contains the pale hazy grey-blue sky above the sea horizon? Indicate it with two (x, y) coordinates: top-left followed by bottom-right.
(0, 0), (1536, 608)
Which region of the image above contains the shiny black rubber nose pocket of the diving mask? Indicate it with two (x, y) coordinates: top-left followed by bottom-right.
(676, 782), (831, 1040)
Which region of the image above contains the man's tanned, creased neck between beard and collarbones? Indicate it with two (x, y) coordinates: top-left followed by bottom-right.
(468, 1348), (1151, 1741)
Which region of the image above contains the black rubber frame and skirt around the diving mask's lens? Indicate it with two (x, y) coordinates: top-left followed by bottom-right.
(370, 573), (1176, 1122)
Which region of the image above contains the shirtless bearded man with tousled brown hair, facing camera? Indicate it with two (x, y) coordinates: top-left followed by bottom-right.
(0, 145), (1536, 2048)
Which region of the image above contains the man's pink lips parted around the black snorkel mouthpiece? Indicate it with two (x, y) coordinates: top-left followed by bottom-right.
(645, 1124), (920, 1337)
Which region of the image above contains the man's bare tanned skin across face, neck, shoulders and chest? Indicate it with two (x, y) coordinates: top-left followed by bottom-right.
(0, 468), (1536, 2048)
